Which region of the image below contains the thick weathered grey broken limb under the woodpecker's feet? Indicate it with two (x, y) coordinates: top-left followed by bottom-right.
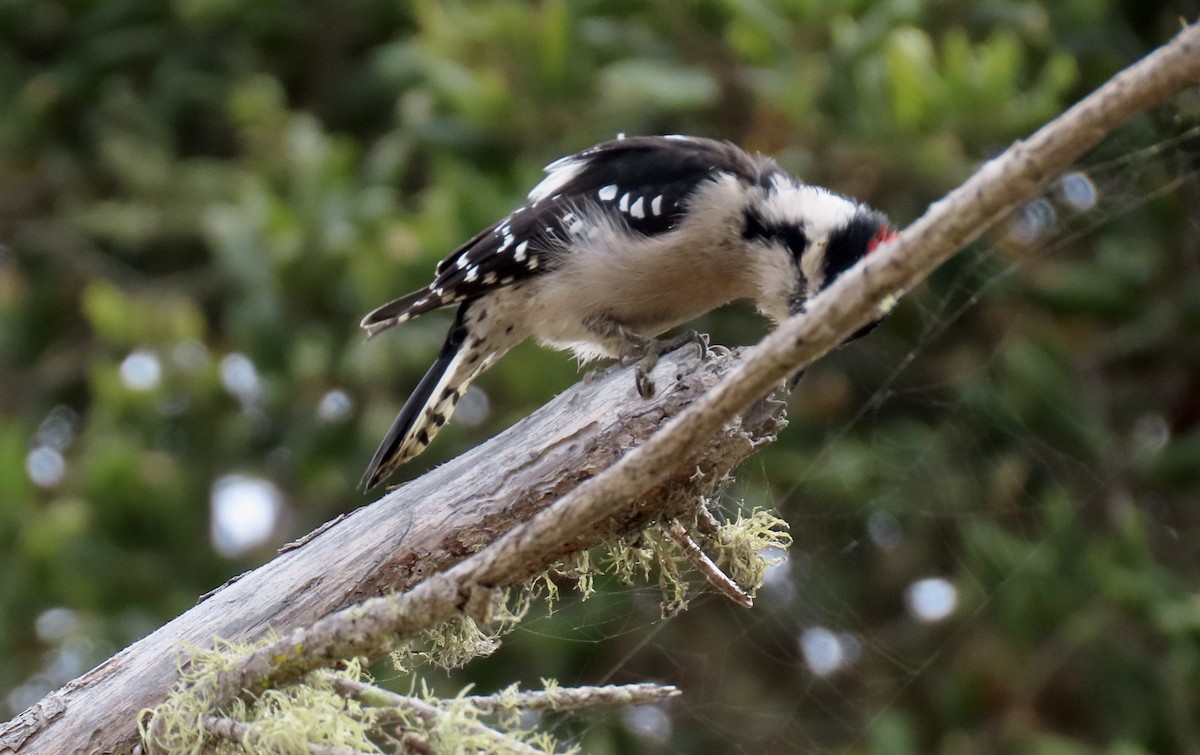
(0, 349), (782, 754)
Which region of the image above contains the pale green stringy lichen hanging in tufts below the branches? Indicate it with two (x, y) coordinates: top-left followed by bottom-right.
(139, 508), (792, 755)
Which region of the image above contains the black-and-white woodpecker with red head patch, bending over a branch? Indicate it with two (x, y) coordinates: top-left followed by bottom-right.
(361, 134), (896, 490)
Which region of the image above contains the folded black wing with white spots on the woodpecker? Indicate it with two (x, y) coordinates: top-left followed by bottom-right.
(362, 136), (779, 335)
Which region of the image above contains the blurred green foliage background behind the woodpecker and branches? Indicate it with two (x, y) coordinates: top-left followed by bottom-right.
(0, 0), (1200, 755)
